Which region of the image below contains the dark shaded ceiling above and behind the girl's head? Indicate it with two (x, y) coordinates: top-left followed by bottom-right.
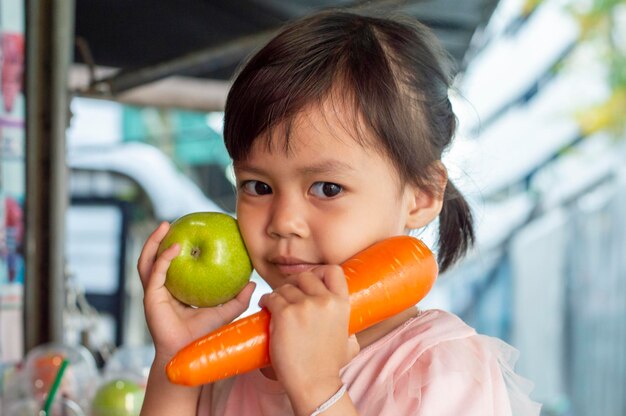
(72, 0), (498, 110)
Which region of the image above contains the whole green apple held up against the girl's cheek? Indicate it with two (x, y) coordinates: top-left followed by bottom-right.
(158, 212), (252, 307)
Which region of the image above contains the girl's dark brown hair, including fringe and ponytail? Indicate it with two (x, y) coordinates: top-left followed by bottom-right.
(224, 11), (474, 271)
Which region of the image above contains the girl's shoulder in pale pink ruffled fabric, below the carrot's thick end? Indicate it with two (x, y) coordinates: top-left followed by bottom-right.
(344, 310), (539, 416)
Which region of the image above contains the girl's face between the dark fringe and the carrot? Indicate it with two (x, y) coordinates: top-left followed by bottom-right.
(235, 106), (415, 288)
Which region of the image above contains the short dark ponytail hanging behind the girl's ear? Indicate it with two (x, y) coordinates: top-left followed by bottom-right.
(438, 181), (474, 272)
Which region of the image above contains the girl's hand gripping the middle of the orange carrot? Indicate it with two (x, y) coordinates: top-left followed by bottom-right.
(260, 266), (359, 406)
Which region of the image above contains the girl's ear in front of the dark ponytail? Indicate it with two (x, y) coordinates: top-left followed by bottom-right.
(405, 162), (448, 229)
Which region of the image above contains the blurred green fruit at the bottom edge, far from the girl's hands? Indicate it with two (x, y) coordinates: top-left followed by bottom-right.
(91, 379), (145, 416)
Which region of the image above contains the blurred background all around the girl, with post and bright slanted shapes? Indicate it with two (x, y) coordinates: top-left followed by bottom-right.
(0, 0), (626, 416)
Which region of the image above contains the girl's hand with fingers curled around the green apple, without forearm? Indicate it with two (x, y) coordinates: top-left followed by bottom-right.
(137, 222), (254, 359)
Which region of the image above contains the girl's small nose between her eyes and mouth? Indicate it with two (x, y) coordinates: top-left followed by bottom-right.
(267, 197), (309, 238)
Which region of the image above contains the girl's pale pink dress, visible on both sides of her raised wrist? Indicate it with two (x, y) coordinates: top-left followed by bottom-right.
(198, 310), (540, 416)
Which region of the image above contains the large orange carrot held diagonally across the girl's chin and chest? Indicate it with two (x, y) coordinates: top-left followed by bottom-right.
(166, 236), (438, 386)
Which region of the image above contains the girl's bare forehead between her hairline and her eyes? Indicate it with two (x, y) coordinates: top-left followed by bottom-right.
(235, 101), (399, 187)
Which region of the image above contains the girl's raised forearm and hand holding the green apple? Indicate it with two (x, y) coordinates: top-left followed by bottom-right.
(137, 222), (254, 416)
